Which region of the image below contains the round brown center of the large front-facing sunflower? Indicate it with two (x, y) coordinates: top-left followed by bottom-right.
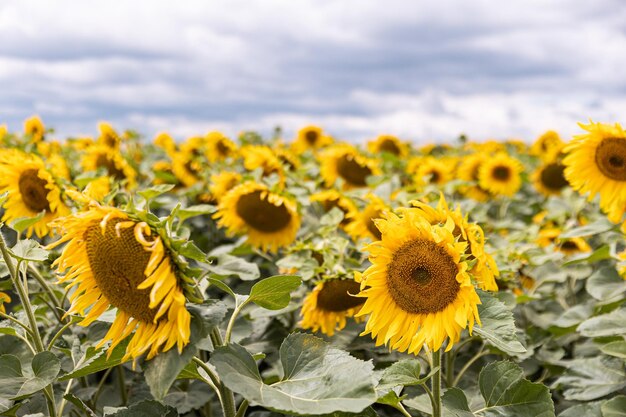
(387, 239), (460, 314)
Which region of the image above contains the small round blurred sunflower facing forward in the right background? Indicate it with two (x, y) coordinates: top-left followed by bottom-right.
(478, 152), (523, 196)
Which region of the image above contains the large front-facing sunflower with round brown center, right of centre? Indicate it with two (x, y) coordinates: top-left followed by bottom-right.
(356, 208), (480, 354)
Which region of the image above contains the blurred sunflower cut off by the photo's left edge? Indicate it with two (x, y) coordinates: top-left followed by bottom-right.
(0, 149), (69, 237)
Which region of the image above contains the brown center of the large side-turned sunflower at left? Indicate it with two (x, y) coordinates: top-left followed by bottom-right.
(83, 219), (156, 323)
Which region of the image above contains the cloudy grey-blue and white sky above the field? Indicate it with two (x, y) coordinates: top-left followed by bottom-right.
(0, 0), (626, 143)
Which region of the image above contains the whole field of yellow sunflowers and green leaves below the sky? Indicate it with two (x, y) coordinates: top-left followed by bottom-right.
(0, 116), (626, 417)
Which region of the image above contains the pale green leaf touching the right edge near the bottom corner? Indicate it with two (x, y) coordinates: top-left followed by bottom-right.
(555, 356), (626, 401)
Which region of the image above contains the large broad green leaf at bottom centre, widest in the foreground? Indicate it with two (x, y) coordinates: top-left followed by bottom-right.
(210, 333), (376, 415)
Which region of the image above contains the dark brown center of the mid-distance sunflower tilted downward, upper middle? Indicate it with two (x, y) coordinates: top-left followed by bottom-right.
(235, 190), (291, 233)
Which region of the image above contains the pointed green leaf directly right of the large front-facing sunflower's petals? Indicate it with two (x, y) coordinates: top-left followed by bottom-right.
(474, 291), (526, 354)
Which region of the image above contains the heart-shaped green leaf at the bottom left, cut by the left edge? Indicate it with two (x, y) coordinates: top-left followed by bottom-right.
(0, 351), (61, 400)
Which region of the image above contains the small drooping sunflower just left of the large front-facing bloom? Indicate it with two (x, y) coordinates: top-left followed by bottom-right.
(300, 279), (365, 336)
